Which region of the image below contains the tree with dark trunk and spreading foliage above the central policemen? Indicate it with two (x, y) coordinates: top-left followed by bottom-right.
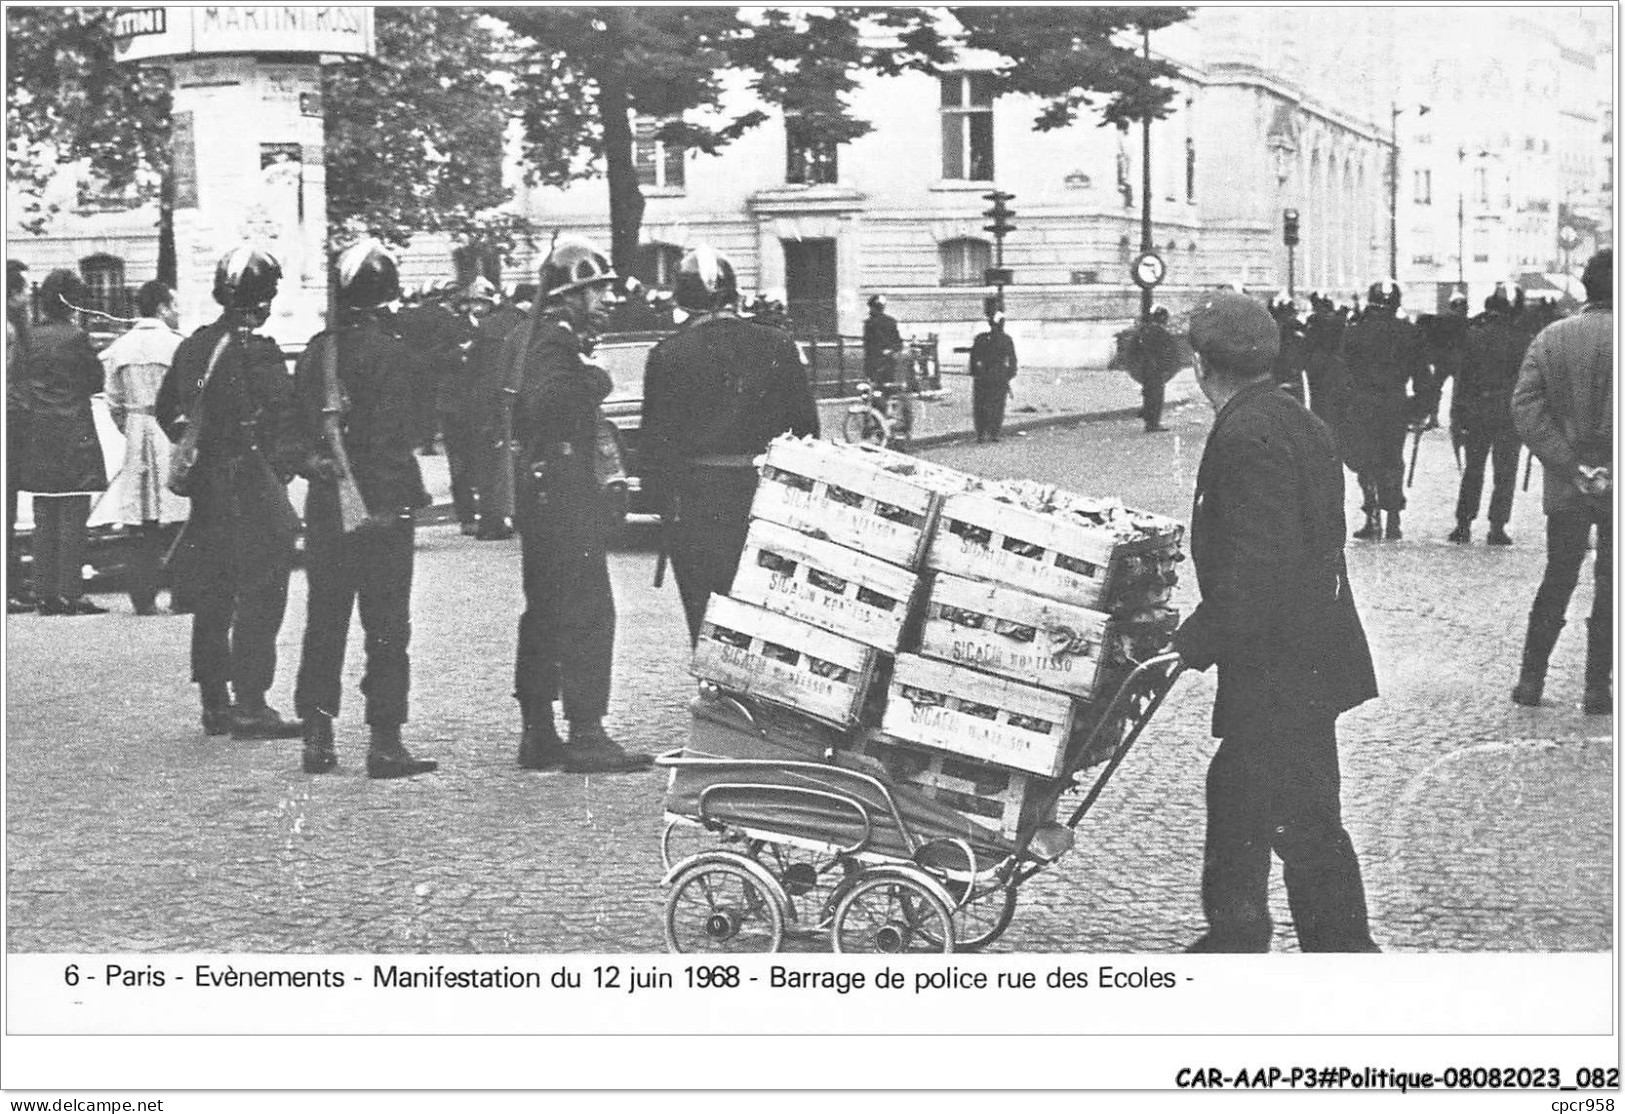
(489, 5), (947, 273)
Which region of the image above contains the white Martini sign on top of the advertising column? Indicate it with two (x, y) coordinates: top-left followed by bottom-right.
(114, 5), (374, 62)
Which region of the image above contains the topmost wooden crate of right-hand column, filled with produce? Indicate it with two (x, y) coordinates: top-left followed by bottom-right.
(926, 492), (1183, 611)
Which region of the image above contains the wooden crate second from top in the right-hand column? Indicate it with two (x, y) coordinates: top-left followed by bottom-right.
(920, 573), (1121, 700)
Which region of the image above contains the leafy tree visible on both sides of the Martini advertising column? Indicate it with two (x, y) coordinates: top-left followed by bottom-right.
(7, 6), (527, 283)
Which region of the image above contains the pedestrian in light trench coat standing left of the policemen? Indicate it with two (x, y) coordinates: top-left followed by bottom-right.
(98, 279), (190, 615)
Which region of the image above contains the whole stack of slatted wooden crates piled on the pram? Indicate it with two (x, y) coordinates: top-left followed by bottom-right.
(672, 437), (1183, 838)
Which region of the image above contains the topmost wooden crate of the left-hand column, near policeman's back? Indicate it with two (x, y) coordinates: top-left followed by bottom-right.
(751, 437), (943, 568)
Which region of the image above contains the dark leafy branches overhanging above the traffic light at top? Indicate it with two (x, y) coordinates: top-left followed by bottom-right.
(951, 5), (1193, 132)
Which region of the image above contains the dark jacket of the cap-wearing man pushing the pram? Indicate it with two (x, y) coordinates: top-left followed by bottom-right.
(1175, 380), (1376, 737)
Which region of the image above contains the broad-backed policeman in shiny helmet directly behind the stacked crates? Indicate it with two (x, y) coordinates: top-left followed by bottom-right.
(644, 247), (819, 641)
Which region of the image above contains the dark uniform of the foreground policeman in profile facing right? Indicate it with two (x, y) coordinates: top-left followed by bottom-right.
(514, 309), (614, 721)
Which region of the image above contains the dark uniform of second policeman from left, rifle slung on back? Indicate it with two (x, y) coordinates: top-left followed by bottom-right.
(294, 310), (429, 728)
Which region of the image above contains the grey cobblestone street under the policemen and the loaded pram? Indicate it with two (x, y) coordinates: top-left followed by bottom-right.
(7, 379), (1614, 952)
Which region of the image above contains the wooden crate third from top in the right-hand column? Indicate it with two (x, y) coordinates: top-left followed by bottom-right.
(881, 654), (1073, 778)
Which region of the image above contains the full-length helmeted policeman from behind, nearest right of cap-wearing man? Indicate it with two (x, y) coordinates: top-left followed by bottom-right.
(1342, 279), (1428, 541)
